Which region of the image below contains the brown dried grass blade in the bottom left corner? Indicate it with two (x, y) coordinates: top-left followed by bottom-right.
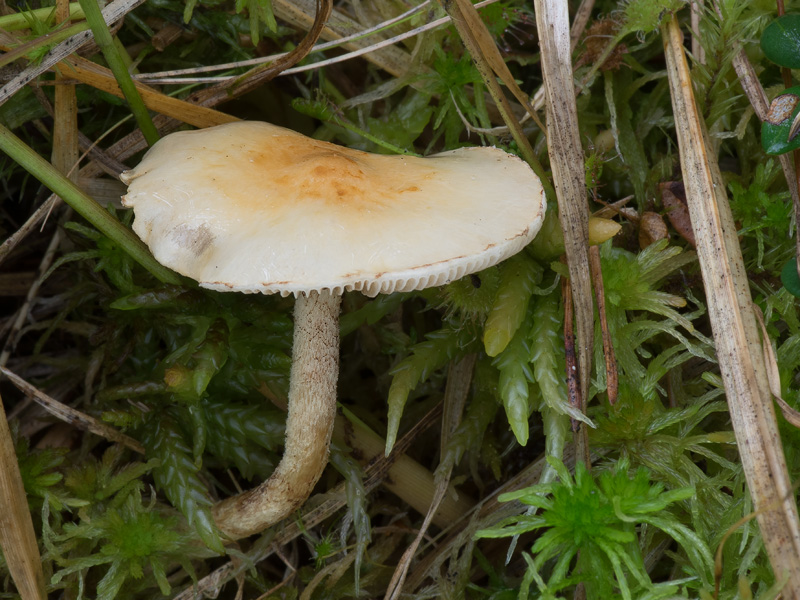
(0, 398), (47, 600)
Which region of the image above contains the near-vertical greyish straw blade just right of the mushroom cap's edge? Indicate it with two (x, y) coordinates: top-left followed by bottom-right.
(534, 0), (594, 408)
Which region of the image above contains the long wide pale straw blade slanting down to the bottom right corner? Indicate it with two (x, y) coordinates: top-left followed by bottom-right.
(661, 18), (800, 600)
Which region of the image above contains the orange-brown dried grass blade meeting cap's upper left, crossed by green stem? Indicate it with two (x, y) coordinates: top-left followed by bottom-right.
(61, 56), (239, 128)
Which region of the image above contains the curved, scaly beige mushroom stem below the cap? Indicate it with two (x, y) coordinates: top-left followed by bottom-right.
(214, 291), (342, 539)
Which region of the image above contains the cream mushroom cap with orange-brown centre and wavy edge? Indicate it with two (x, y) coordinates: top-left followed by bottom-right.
(121, 122), (545, 296)
